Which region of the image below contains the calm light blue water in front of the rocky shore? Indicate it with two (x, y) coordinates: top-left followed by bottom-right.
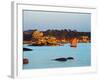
(23, 43), (91, 69)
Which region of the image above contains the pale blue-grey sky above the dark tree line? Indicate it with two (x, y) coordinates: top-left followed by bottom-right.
(23, 10), (91, 32)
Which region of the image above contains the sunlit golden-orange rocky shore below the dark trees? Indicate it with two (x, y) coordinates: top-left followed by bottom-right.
(23, 31), (91, 46)
